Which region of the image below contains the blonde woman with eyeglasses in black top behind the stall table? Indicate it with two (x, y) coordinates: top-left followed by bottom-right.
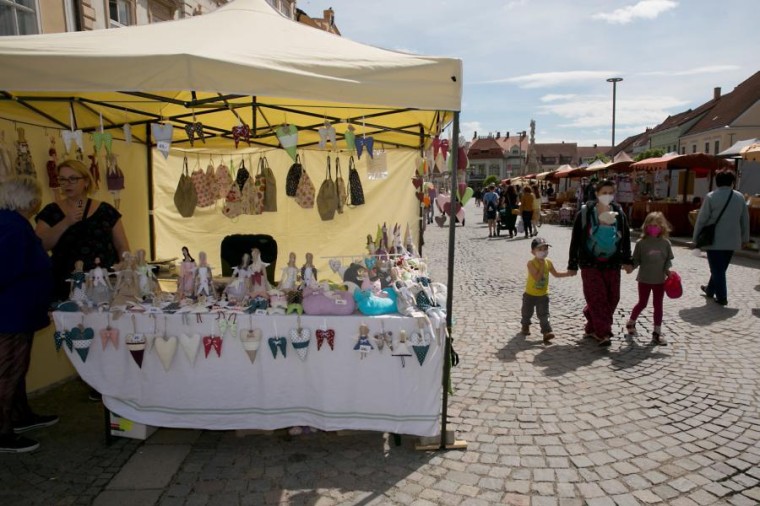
(35, 160), (129, 300)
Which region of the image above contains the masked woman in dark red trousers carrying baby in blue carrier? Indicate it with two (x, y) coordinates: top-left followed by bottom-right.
(567, 180), (633, 346)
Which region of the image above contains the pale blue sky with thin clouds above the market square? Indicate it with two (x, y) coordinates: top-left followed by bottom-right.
(298, 0), (760, 146)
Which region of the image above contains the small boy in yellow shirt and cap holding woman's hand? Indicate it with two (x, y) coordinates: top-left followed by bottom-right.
(521, 237), (572, 343)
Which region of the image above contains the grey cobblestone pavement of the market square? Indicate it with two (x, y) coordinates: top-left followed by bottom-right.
(5, 203), (760, 506)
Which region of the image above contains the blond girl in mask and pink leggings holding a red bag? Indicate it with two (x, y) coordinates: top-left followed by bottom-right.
(625, 211), (673, 346)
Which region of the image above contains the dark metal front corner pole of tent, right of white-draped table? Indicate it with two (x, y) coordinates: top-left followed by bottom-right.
(440, 111), (459, 450)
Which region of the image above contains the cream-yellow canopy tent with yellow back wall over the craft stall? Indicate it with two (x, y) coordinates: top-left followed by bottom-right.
(0, 0), (462, 442)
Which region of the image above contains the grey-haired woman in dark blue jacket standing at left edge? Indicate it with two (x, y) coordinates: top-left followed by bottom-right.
(0, 177), (58, 453)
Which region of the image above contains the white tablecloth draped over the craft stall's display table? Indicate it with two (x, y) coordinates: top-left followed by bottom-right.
(53, 312), (444, 436)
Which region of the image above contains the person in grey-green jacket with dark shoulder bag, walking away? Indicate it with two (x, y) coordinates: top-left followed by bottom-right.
(692, 170), (749, 306)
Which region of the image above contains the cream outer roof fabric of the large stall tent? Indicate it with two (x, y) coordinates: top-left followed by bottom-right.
(0, 0), (462, 111)
